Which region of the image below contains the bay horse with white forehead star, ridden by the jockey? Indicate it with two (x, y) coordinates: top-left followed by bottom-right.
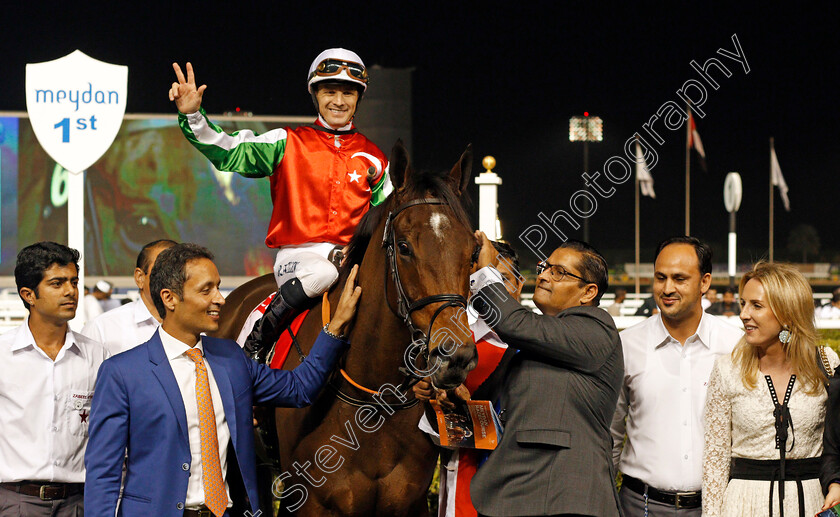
(219, 141), (477, 516)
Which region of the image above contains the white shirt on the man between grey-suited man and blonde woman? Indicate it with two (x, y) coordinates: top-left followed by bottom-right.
(611, 312), (743, 491)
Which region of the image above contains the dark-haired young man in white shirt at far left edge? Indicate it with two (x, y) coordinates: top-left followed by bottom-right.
(0, 242), (110, 517)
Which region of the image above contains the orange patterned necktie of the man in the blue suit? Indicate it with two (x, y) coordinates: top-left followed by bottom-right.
(186, 348), (228, 517)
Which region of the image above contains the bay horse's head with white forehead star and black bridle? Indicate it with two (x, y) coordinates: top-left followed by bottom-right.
(383, 141), (478, 389)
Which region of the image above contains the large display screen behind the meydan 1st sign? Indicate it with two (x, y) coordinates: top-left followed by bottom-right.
(0, 116), (308, 276)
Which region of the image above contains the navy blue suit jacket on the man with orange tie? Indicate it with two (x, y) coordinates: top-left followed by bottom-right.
(85, 332), (346, 517)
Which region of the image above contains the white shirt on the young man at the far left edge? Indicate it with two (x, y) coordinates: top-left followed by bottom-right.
(0, 318), (111, 483)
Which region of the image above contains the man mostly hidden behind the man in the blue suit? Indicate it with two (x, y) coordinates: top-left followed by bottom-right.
(82, 239), (177, 354)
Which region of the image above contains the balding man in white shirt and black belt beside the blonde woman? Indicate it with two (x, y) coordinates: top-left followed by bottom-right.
(611, 237), (742, 517)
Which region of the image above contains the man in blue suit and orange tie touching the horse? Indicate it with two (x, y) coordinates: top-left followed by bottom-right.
(85, 244), (361, 517)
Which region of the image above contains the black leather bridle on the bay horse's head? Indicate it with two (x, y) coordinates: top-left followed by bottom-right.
(382, 197), (467, 379)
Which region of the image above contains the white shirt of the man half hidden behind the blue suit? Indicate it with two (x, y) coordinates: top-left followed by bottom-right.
(82, 298), (160, 354)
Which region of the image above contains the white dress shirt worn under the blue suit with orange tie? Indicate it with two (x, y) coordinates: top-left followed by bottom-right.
(160, 328), (233, 509)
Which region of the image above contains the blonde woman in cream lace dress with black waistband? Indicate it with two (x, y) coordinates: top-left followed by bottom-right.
(703, 262), (840, 517)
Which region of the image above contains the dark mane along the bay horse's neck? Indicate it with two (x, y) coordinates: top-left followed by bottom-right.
(342, 171), (472, 276)
